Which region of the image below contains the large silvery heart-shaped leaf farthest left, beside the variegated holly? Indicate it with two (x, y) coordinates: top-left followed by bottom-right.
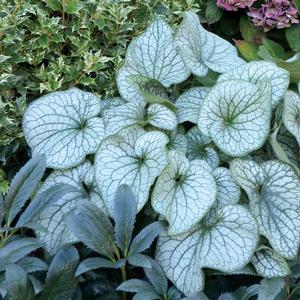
(23, 88), (104, 169)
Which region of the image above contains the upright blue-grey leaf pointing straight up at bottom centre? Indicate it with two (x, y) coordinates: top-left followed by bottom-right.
(113, 185), (137, 255)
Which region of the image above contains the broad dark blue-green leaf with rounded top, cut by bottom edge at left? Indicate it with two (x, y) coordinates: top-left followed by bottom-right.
(41, 246), (79, 300)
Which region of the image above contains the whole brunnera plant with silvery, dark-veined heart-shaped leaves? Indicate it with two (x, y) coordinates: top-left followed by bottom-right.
(23, 12), (300, 296)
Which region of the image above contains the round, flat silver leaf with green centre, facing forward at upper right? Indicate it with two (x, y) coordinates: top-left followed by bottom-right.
(198, 80), (271, 156)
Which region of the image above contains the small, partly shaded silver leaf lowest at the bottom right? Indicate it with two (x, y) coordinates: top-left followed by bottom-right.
(251, 247), (291, 278)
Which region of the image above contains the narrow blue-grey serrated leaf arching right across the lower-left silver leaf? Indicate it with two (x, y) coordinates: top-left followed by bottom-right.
(16, 184), (77, 228)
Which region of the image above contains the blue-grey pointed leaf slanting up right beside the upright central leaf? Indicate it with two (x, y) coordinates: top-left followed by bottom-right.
(129, 222), (165, 255)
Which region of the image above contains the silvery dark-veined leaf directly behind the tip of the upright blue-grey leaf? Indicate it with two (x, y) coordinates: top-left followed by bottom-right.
(95, 126), (168, 214)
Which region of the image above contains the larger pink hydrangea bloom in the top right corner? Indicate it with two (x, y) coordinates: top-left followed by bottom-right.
(248, 0), (299, 31)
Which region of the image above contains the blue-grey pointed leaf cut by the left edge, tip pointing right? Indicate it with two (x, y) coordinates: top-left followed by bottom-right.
(0, 238), (43, 271)
